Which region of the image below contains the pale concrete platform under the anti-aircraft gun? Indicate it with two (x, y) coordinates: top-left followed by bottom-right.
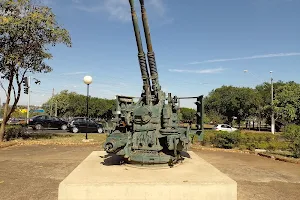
(58, 151), (237, 200)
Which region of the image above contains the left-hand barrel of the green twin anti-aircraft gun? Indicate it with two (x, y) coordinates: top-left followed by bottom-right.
(129, 0), (150, 103)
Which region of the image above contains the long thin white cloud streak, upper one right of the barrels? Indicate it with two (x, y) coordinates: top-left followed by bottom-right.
(189, 52), (300, 65)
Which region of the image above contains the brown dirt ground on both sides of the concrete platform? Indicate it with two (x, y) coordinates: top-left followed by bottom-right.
(0, 145), (300, 200)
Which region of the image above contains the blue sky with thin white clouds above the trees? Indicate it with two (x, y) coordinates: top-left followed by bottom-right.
(1, 0), (300, 108)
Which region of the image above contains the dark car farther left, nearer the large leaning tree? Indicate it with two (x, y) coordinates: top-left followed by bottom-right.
(28, 115), (68, 130)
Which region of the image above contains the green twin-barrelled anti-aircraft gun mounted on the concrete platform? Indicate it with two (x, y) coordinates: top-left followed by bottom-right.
(104, 0), (199, 164)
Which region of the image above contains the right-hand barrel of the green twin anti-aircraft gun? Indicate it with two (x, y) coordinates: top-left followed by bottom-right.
(140, 0), (159, 89)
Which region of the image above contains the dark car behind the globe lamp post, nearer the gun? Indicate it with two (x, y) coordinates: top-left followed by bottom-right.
(68, 117), (103, 133)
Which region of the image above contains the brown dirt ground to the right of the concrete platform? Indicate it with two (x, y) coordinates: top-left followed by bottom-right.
(197, 150), (300, 200)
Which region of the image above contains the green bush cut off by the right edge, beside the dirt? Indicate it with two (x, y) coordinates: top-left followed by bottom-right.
(284, 124), (300, 158)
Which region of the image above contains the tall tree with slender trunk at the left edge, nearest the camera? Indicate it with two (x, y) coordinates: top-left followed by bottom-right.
(0, 0), (71, 141)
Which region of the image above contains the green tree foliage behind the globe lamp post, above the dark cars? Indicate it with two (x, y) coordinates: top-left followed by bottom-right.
(43, 90), (115, 117)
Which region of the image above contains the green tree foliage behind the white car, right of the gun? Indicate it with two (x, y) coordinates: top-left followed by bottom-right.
(204, 81), (300, 131)
